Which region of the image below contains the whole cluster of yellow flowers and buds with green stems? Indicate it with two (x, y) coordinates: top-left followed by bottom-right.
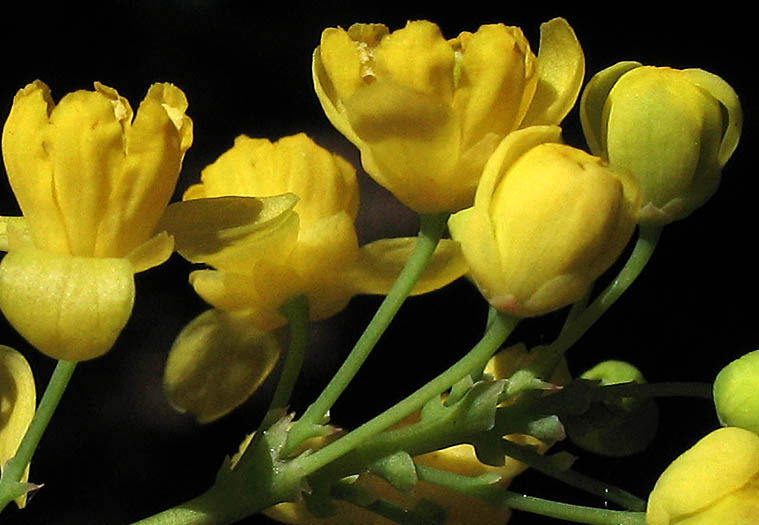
(0, 9), (744, 525)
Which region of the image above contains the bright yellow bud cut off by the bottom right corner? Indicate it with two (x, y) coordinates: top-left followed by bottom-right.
(646, 427), (759, 525)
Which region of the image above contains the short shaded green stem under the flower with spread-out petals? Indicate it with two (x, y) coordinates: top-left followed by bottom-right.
(258, 295), (311, 432)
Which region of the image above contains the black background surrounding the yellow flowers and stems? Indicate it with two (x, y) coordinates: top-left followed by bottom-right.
(0, 0), (759, 525)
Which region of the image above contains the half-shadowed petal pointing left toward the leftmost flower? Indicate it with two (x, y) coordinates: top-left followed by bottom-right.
(158, 194), (298, 274)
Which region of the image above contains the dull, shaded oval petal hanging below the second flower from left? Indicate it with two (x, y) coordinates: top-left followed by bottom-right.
(164, 310), (280, 423)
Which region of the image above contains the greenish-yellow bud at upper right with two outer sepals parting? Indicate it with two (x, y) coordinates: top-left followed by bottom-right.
(580, 62), (743, 224)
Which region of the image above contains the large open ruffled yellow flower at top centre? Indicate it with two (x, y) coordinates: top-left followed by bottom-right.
(313, 18), (585, 213)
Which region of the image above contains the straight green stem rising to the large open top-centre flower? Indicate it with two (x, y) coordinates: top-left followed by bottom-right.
(285, 213), (449, 454)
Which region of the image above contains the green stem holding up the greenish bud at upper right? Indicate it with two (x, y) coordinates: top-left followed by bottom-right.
(528, 226), (662, 377)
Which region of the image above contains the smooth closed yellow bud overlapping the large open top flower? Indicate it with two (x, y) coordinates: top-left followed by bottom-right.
(449, 126), (639, 317)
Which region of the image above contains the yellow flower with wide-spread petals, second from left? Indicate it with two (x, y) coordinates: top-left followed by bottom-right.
(161, 134), (466, 422)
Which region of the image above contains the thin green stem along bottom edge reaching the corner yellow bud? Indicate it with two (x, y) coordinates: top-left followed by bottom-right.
(416, 465), (646, 525)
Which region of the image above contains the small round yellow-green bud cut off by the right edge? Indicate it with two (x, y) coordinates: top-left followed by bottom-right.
(713, 350), (759, 434)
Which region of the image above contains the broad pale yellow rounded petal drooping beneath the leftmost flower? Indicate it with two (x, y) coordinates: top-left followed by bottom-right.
(0, 246), (134, 361)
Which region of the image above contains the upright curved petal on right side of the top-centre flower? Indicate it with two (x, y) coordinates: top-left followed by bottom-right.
(521, 18), (585, 127)
